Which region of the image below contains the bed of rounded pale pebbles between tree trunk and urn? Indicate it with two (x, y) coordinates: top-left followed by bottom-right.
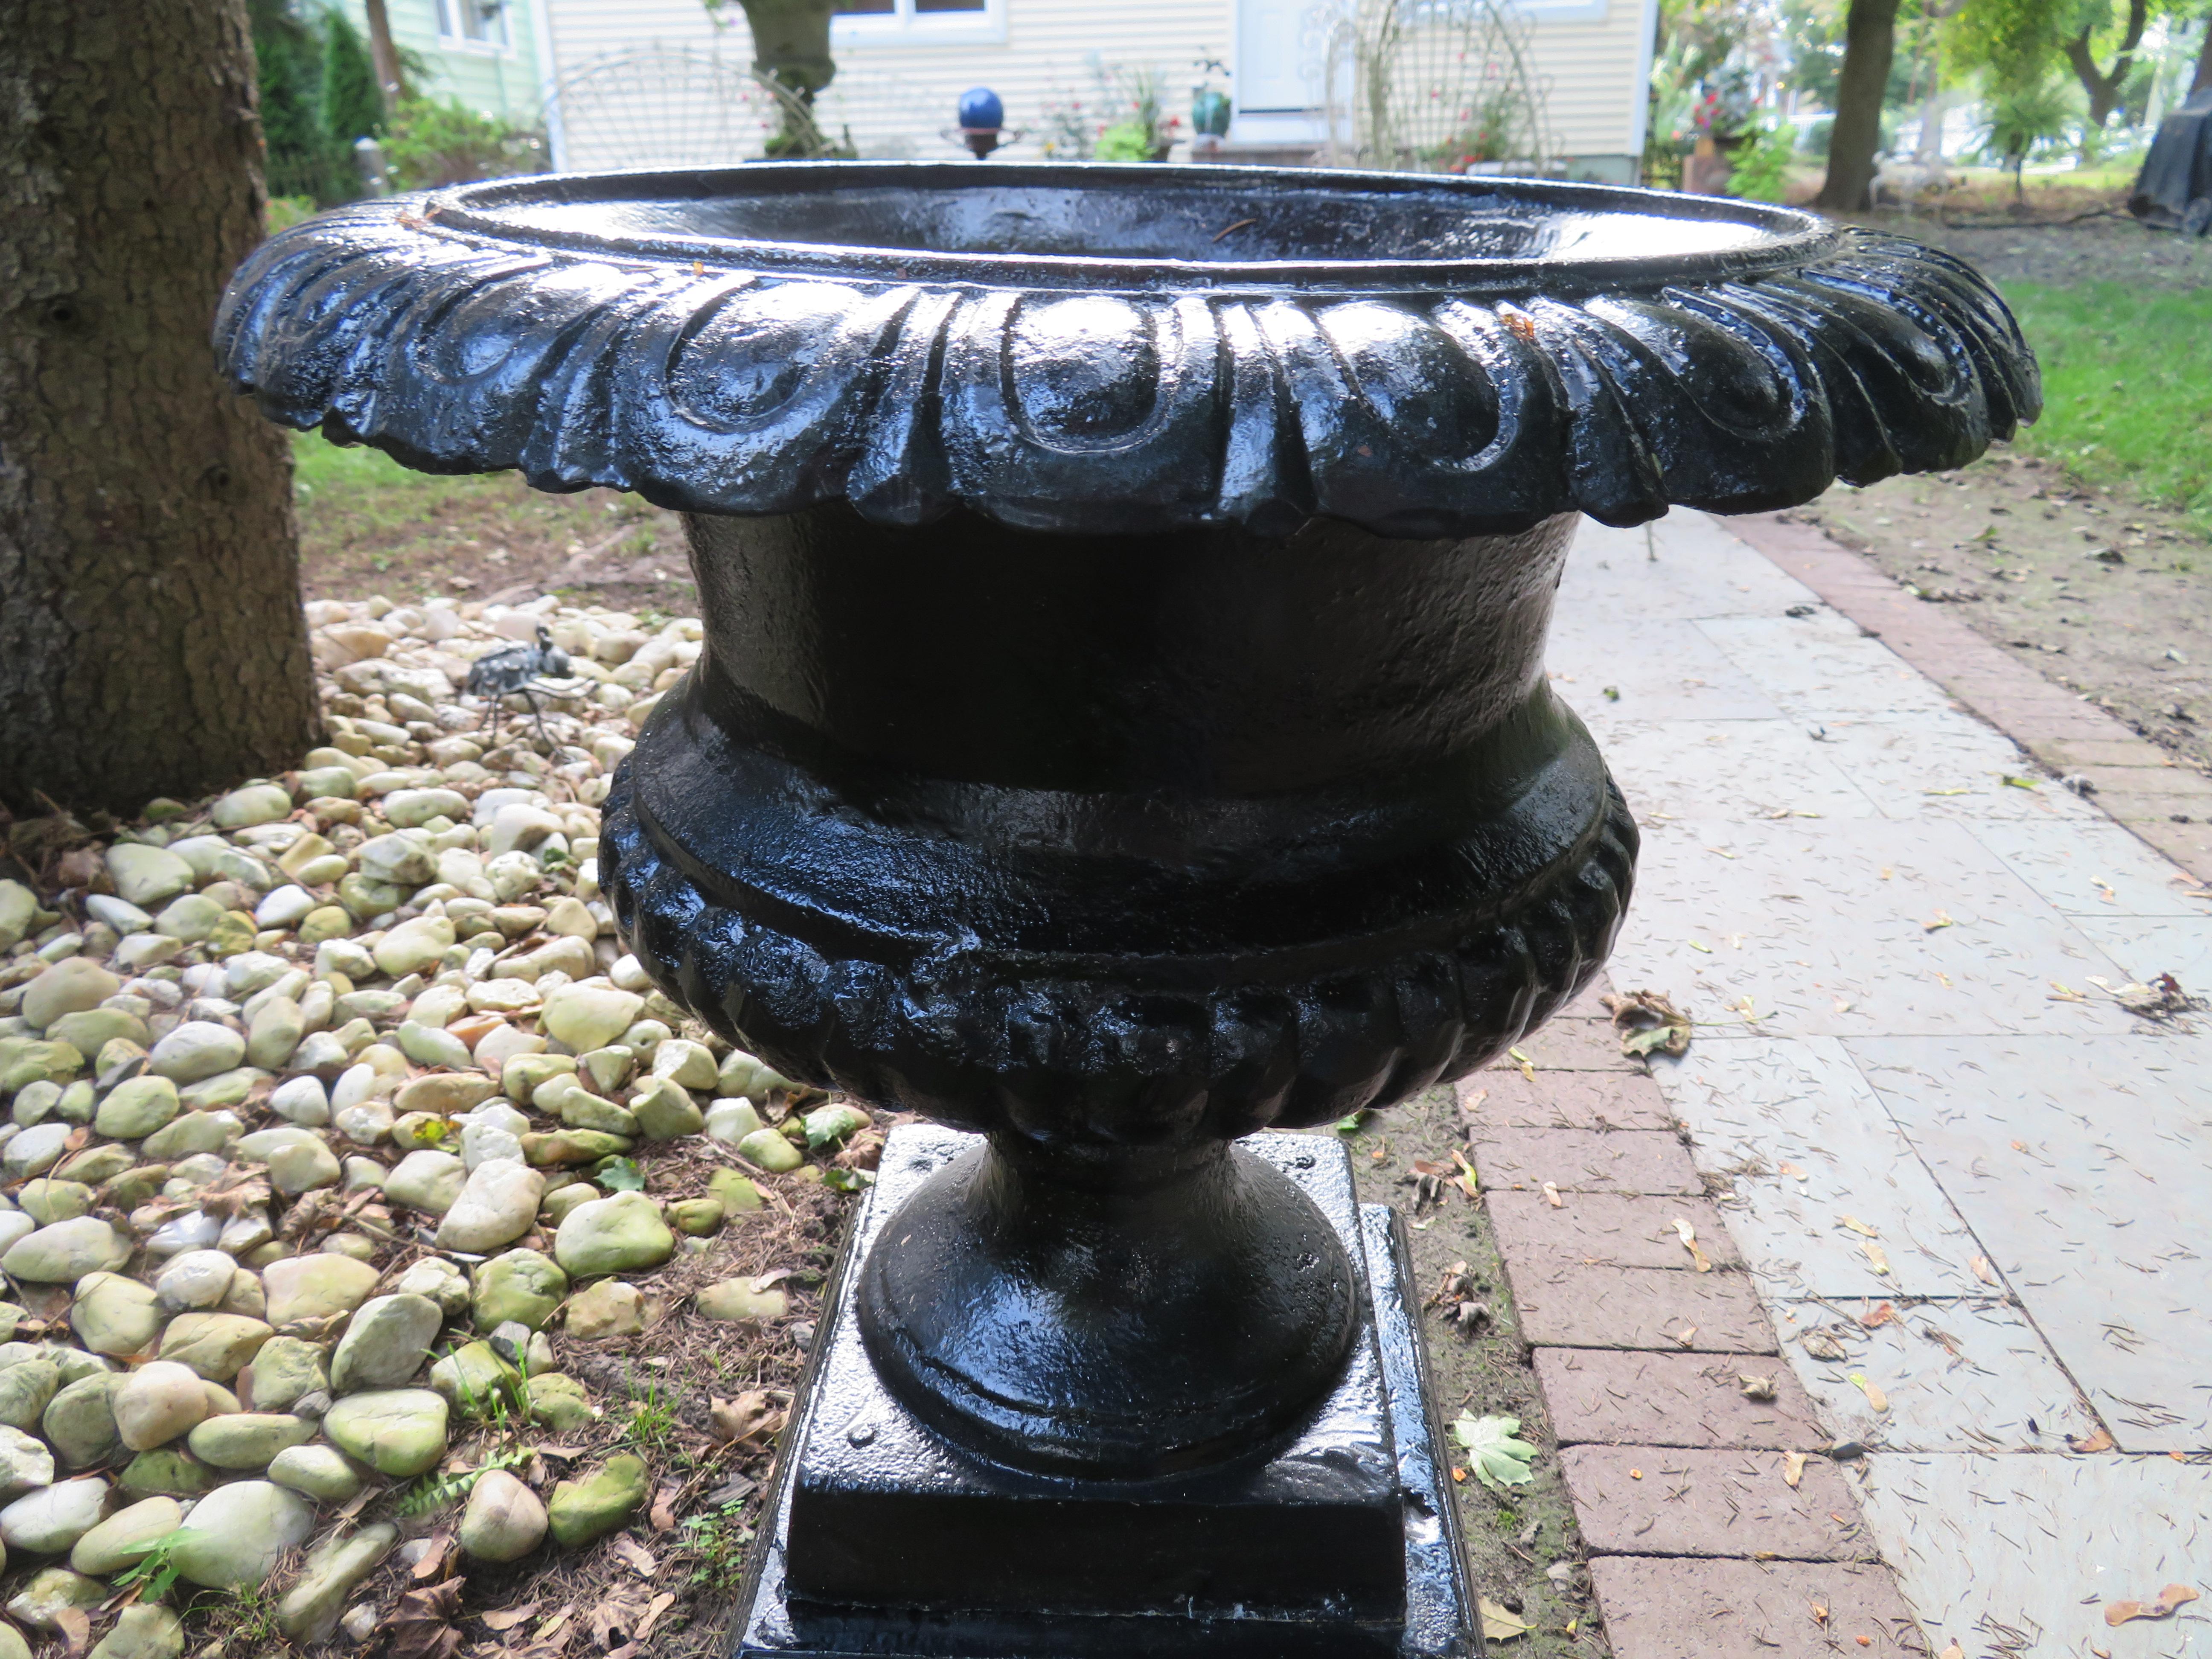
(0, 597), (880, 1659)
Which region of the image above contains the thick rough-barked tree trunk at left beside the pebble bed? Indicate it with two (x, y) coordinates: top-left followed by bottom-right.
(0, 0), (321, 809)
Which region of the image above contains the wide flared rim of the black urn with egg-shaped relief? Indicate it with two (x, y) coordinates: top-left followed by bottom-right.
(217, 164), (2042, 538)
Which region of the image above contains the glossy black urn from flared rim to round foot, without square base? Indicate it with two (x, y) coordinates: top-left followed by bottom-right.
(219, 164), (2037, 1478)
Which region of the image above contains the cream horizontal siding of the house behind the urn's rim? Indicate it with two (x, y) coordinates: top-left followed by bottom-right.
(542, 0), (1655, 177)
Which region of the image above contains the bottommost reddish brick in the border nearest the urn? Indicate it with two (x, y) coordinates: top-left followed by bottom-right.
(1590, 1555), (1929, 1659)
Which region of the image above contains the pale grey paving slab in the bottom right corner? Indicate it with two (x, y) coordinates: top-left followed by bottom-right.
(1860, 1453), (2212, 1659)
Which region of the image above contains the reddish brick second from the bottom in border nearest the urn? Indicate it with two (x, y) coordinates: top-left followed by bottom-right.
(1560, 1447), (1874, 1562)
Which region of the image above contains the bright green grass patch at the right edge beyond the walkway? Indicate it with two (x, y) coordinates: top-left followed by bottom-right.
(2004, 283), (2212, 531)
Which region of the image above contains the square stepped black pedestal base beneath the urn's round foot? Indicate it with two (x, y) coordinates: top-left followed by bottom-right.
(734, 1126), (1480, 1659)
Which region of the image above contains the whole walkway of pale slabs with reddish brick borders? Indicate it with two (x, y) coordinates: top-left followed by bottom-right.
(1486, 513), (2212, 1659)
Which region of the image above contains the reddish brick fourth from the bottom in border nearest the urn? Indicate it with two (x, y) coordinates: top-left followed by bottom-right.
(1506, 1263), (1774, 1354)
